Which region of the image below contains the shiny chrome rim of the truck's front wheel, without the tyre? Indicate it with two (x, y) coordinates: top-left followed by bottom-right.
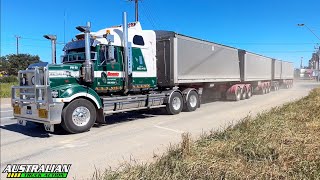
(72, 106), (90, 126)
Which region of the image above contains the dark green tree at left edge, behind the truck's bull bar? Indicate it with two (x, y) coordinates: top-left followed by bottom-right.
(0, 54), (41, 75)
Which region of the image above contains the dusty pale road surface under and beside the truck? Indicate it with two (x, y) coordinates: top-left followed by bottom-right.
(0, 81), (320, 179)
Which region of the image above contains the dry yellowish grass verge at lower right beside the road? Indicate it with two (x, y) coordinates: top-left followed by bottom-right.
(99, 89), (320, 180)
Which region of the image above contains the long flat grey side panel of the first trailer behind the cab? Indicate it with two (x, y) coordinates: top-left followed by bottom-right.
(175, 36), (240, 84)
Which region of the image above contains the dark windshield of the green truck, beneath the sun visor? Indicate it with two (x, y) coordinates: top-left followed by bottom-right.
(61, 48), (97, 63)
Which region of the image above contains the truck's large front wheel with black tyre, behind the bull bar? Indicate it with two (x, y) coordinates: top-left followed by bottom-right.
(61, 99), (96, 133)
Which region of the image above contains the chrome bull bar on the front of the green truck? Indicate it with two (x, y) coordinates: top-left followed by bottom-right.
(11, 66), (63, 131)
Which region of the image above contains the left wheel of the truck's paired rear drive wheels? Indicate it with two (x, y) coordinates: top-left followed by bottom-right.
(166, 92), (183, 115)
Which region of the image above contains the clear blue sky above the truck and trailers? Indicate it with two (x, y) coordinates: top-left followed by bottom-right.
(0, 0), (320, 67)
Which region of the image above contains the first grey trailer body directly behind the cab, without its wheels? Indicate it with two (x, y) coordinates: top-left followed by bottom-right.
(155, 31), (240, 87)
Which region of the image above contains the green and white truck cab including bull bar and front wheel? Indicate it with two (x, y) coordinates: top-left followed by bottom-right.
(12, 16), (171, 133)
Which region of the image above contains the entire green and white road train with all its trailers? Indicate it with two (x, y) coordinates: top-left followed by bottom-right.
(12, 12), (293, 133)
